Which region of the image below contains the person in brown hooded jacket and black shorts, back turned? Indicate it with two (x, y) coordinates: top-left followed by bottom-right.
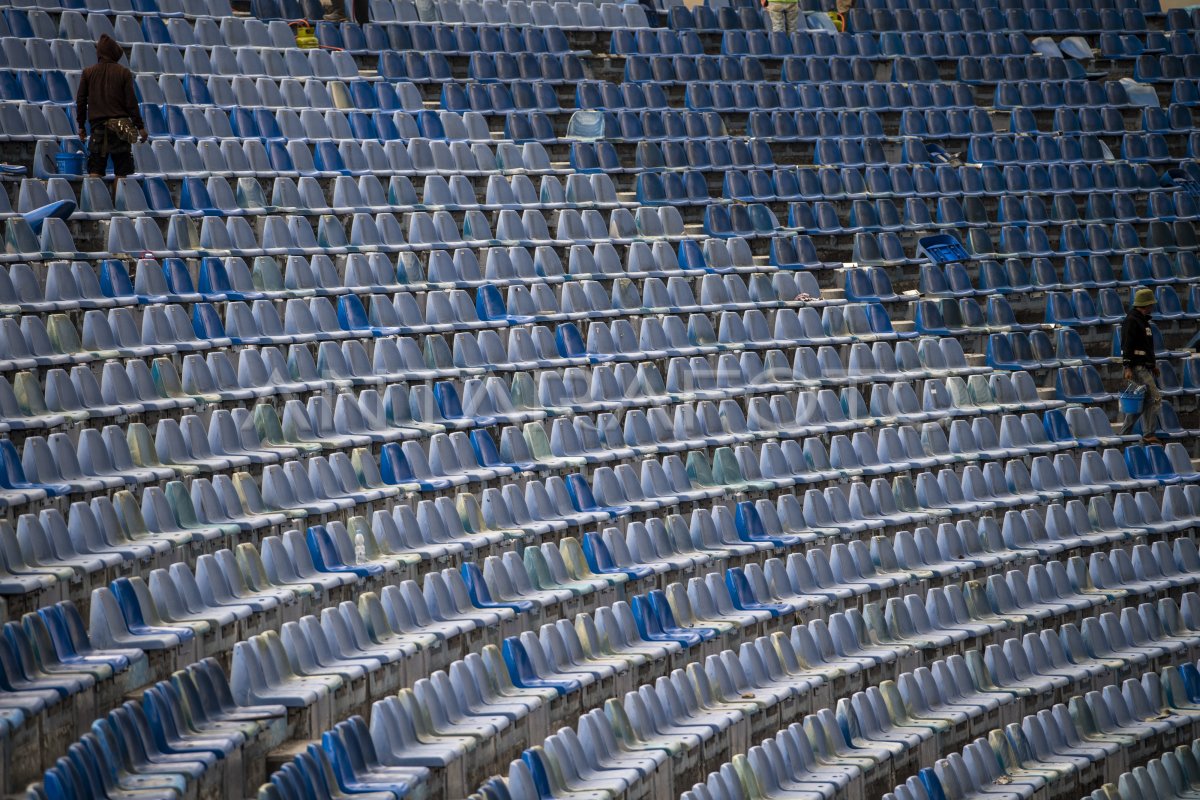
(76, 34), (146, 178)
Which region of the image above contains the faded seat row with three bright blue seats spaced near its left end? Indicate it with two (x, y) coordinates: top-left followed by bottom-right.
(0, 239), (777, 313)
